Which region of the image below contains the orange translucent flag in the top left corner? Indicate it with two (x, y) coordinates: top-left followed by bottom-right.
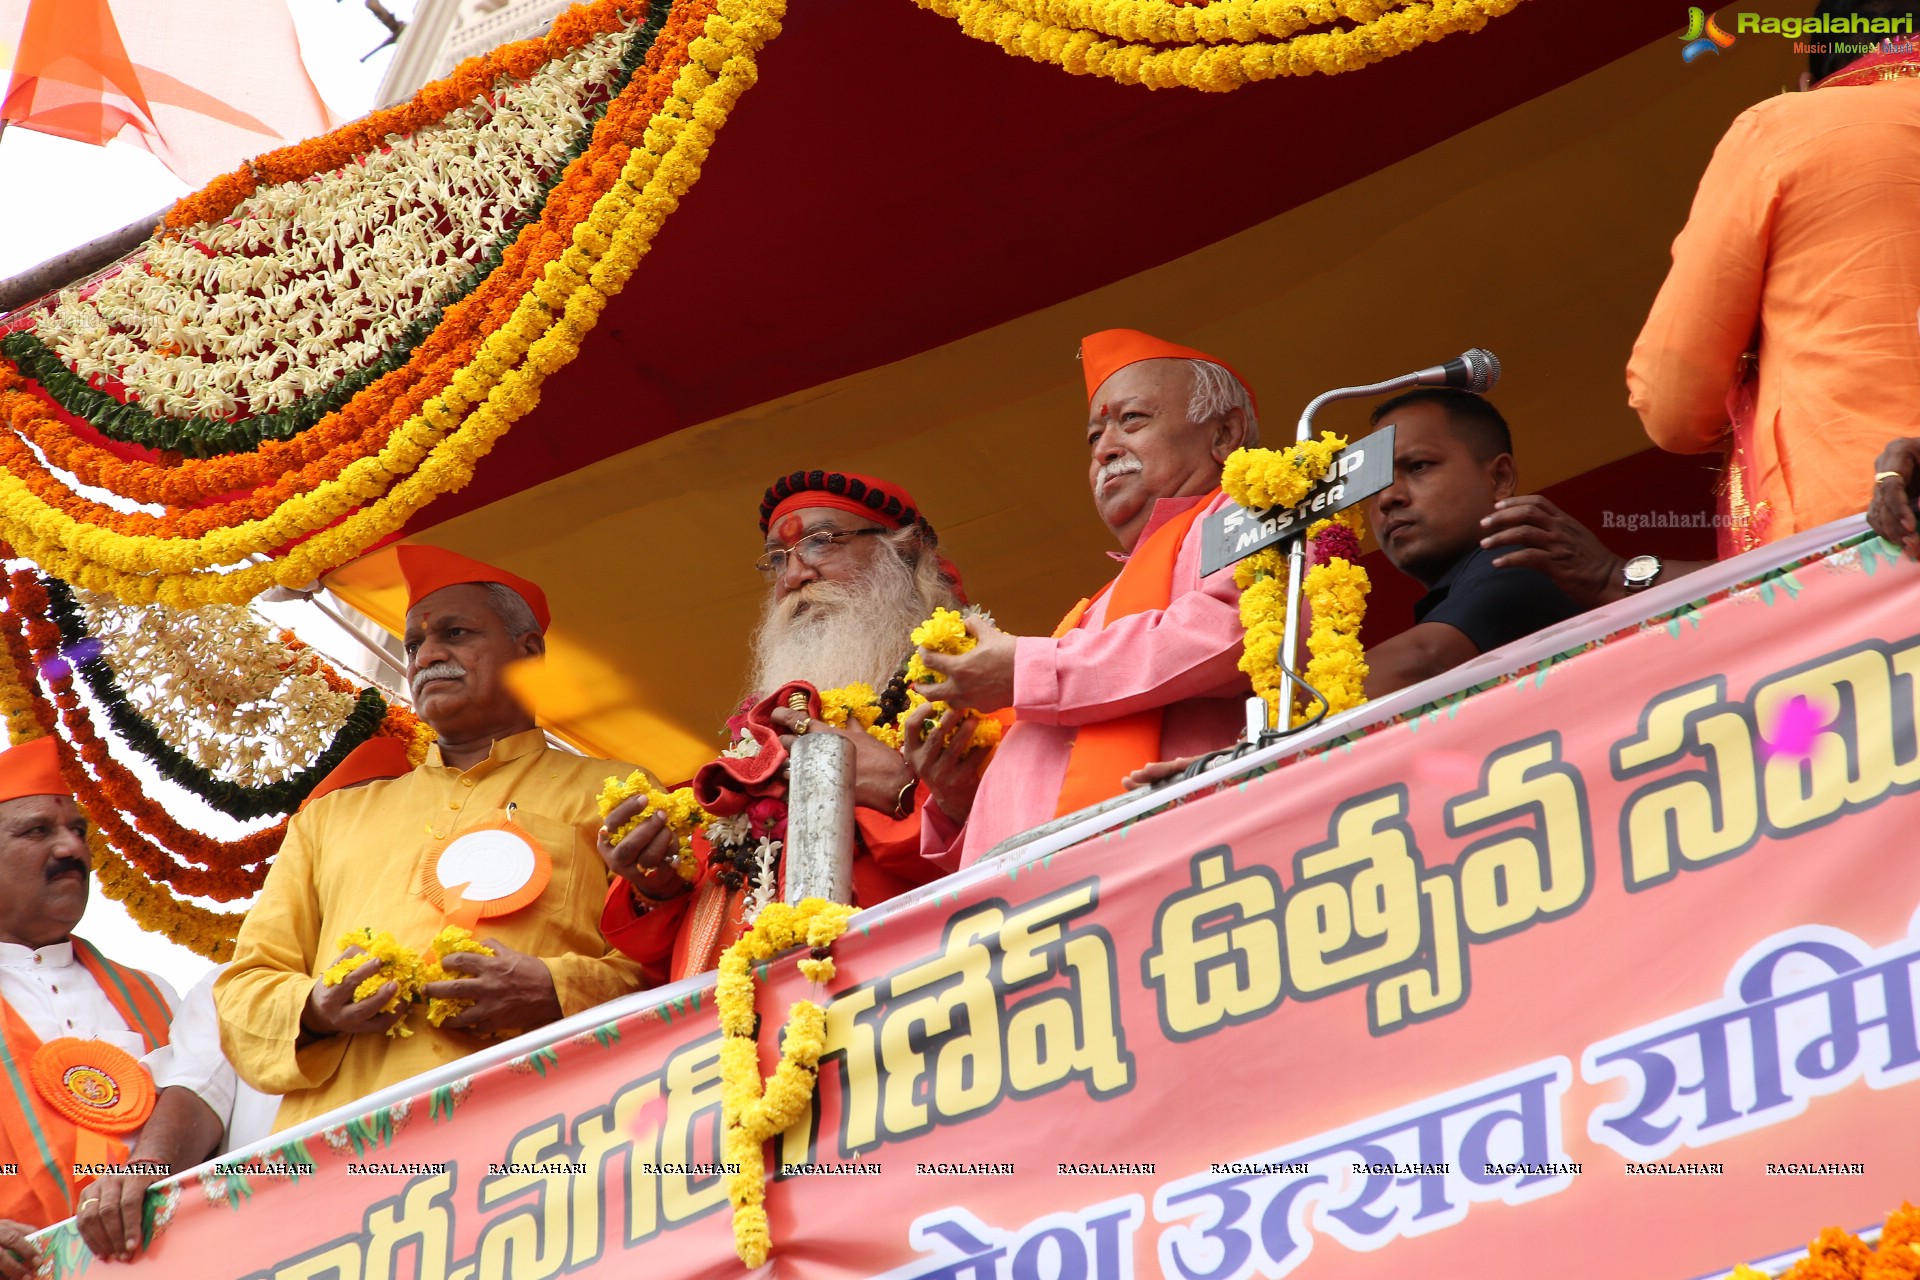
(0, 0), (336, 186)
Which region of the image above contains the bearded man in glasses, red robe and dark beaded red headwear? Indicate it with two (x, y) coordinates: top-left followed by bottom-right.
(601, 470), (985, 979)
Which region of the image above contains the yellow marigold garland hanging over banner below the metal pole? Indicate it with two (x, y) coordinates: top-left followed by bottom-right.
(714, 898), (854, 1267)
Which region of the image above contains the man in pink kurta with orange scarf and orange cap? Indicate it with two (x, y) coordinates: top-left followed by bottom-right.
(906, 330), (1258, 869)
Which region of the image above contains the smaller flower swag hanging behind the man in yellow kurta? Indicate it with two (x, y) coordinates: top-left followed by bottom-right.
(0, 560), (430, 960)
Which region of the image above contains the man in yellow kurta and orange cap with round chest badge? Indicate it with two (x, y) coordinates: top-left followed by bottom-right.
(215, 547), (641, 1128)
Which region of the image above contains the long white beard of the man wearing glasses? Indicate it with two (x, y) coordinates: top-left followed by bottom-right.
(751, 553), (931, 695)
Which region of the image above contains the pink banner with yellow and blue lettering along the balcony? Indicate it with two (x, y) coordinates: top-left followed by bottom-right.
(18, 529), (1920, 1280)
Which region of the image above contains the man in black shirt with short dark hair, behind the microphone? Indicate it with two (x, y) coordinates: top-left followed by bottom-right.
(1367, 388), (1699, 699)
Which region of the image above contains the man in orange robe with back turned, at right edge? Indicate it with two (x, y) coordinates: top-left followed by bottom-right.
(1626, 16), (1920, 551)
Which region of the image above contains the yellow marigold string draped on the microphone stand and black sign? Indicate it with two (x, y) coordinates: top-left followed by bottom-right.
(1221, 432), (1371, 723)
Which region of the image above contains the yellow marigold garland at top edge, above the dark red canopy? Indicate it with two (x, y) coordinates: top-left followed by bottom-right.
(914, 0), (1521, 92)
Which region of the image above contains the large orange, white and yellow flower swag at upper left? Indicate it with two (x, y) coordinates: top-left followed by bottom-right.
(0, 0), (785, 606)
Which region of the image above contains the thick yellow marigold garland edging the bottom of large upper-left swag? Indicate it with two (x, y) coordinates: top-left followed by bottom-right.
(0, 0), (785, 606)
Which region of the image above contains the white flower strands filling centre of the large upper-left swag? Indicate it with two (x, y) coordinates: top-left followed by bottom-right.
(35, 31), (632, 418)
